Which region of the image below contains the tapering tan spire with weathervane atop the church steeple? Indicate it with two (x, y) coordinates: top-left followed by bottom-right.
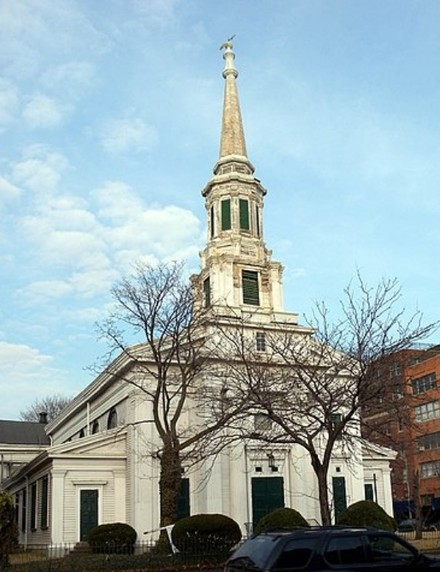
(220, 34), (247, 161)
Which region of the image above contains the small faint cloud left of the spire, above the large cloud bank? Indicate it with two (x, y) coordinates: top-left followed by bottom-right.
(101, 117), (157, 153)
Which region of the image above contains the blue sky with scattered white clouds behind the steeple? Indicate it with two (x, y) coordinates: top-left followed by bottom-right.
(0, 0), (440, 419)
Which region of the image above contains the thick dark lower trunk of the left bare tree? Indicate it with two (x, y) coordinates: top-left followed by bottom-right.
(159, 440), (182, 527)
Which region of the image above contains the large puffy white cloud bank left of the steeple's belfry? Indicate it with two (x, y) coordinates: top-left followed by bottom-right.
(13, 175), (201, 304)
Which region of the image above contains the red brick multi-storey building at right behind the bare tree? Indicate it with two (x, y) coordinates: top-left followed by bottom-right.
(364, 345), (440, 520)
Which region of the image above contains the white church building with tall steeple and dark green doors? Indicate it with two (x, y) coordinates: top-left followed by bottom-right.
(3, 42), (394, 545)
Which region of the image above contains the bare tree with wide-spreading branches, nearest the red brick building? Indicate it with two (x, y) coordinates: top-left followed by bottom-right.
(218, 275), (435, 524)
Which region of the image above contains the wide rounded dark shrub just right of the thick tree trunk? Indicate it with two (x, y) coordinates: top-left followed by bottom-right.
(171, 514), (241, 554)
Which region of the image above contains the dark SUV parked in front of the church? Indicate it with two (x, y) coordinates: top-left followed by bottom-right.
(225, 526), (440, 572)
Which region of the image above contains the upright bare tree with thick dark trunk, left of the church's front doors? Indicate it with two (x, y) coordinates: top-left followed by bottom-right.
(98, 263), (251, 526)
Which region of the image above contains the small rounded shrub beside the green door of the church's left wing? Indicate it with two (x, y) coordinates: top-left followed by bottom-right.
(87, 522), (137, 554)
